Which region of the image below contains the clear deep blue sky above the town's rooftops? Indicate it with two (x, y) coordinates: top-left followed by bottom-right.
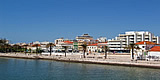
(0, 0), (160, 43)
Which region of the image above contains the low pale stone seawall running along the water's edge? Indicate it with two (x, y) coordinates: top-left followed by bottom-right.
(0, 54), (160, 69)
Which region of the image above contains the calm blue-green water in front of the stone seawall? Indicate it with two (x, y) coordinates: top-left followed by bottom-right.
(0, 58), (160, 80)
